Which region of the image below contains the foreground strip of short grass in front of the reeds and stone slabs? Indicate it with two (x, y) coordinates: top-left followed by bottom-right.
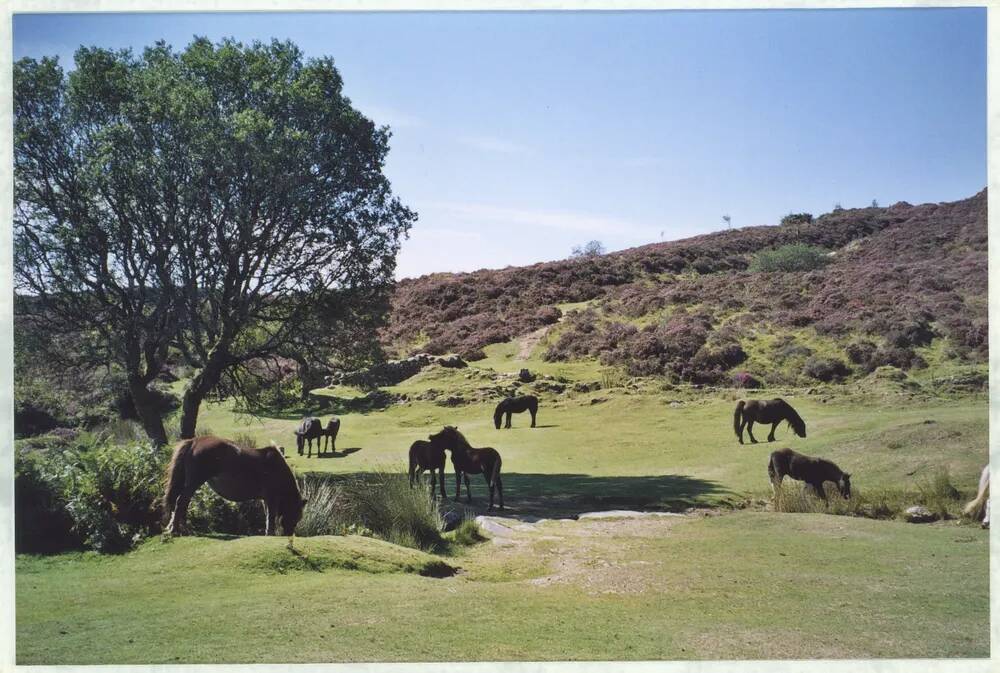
(16, 512), (989, 664)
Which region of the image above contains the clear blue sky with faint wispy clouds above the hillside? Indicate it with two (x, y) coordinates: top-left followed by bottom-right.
(14, 8), (987, 277)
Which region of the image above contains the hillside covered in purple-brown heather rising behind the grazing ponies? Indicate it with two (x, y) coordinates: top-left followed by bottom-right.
(383, 190), (987, 387)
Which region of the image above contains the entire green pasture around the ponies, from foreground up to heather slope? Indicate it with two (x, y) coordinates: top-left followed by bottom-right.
(16, 354), (989, 664)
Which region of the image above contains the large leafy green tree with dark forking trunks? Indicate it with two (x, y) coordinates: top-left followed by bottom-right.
(15, 39), (416, 441)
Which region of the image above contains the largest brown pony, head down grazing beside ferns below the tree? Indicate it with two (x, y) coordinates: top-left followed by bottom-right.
(163, 437), (306, 535)
